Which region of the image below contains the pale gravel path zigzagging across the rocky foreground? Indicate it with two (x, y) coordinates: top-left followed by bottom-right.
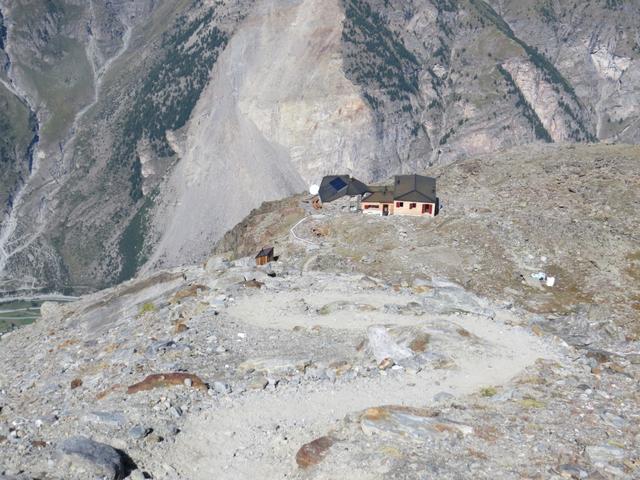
(164, 285), (560, 480)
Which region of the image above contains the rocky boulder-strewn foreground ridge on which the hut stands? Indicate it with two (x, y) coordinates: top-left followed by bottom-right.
(0, 146), (640, 479)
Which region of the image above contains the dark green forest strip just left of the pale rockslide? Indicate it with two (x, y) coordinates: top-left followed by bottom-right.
(110, 4), (228, 282)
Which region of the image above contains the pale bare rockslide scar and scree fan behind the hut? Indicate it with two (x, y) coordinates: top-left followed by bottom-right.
(150, 0), (380, 266)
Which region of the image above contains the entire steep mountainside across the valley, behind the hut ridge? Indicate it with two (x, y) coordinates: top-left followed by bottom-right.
(0, 0), (640, 290)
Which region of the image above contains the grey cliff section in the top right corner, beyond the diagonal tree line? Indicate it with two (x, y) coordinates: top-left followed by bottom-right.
(496, 0), (640, 143)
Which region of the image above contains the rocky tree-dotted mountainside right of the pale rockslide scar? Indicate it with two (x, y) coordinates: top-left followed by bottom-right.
(344, 0), (639, 167)
